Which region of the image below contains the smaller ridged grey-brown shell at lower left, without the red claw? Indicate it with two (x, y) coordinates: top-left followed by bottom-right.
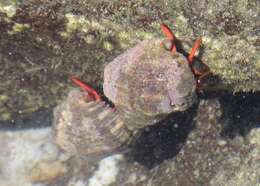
(53, 89), (132, 155)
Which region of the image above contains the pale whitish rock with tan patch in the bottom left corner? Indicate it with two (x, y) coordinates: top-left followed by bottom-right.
(0, 128), (67, 186)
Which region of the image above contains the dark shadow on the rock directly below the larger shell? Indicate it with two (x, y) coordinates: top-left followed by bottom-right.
(127, 105), (197, 169)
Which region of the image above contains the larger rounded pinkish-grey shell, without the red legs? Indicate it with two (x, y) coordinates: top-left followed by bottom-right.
(103, 39), (196, 130)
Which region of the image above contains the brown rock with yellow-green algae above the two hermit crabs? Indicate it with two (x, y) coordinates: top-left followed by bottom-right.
(0, 0), (260, 123)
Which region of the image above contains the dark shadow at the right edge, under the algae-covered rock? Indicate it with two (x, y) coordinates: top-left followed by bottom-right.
(220, 92), (260, 139)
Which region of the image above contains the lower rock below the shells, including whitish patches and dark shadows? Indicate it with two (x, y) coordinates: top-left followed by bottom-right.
(0, 92), (260, 186)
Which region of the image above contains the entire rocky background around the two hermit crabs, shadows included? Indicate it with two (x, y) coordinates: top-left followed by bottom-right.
(0, 0), (260, 186)
